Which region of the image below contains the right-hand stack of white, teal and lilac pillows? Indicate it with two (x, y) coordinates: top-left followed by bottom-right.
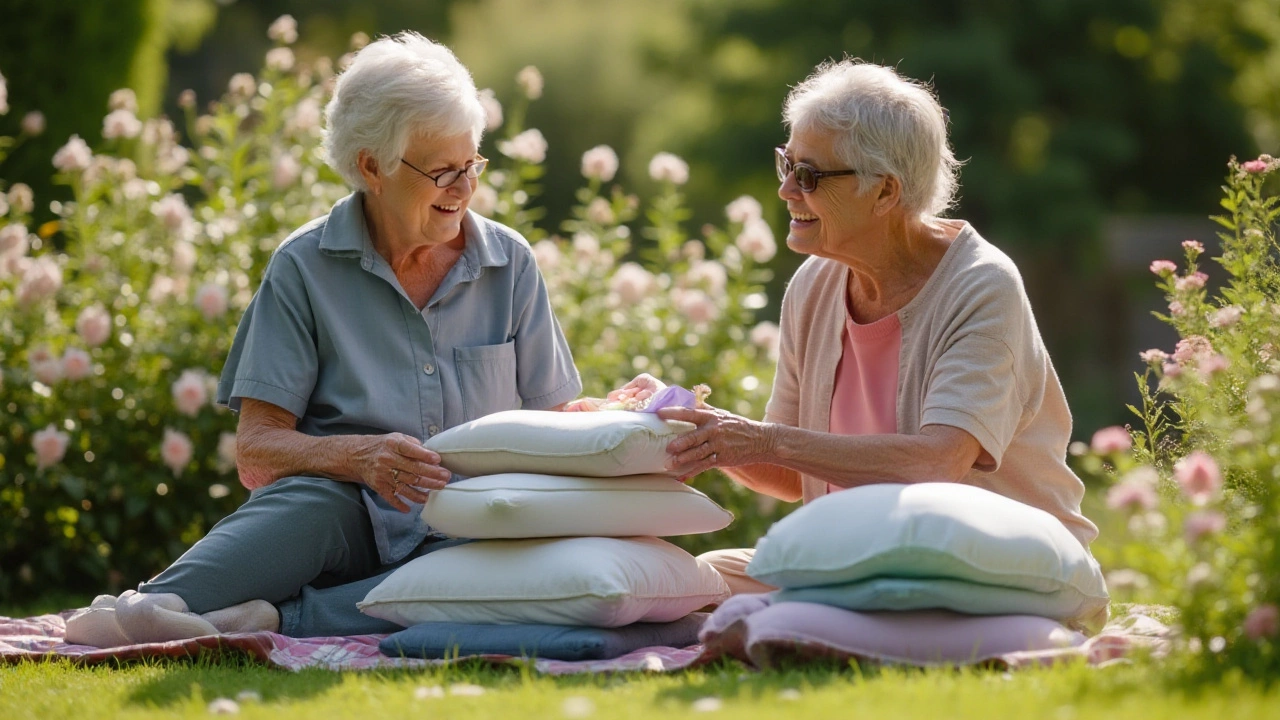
(701, 483), (1108, 666)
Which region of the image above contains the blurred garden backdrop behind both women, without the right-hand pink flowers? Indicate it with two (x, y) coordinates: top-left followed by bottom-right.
(0, 0), (1280, 676)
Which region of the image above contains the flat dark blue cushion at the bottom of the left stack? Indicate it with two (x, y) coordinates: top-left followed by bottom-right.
(378, 612), (708, 661)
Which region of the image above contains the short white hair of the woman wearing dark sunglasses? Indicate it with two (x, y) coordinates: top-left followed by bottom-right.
(782, 59), (960, 217)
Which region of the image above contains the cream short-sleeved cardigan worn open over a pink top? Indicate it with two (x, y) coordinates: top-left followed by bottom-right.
(764, 224), (1098, 547)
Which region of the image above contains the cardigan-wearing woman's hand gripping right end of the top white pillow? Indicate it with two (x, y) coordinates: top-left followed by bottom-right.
(658, 407), (769, 480)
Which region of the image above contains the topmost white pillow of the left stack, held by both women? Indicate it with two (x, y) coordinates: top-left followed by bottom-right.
(424, 410), (694, 478)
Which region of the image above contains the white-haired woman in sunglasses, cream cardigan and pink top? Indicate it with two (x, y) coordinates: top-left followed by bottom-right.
(611, 60), (1097, 592)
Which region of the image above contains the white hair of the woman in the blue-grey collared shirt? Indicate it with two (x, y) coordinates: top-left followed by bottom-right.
(324, 31), (485, 190)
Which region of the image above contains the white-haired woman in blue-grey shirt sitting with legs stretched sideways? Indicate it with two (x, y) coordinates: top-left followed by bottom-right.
(68, 32), (581, 643)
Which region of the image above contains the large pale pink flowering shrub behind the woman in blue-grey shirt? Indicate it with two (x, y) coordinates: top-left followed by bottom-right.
(0, 17), (777, 598)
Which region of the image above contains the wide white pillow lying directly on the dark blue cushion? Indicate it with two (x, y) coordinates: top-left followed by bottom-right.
(357, 538), (730, 628)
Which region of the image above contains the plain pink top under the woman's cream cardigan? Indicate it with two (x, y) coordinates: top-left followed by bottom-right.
(827, 304), (902, 493)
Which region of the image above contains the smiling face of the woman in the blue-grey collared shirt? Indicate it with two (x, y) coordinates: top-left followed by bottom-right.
(378, 133), (479, 246)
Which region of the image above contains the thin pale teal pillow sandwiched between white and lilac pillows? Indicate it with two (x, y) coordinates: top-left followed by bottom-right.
(773, 578), (1106, 633)
